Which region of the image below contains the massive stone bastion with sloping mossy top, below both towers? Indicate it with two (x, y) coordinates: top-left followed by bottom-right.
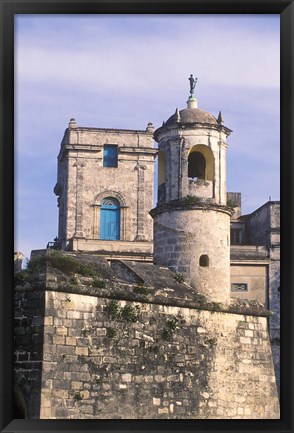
(15, 252), (279, 419)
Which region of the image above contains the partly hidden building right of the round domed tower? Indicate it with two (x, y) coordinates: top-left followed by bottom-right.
(228, 197), (280, 392)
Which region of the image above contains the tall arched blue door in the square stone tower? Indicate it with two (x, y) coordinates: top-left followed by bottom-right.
(100, 197), (120, 241)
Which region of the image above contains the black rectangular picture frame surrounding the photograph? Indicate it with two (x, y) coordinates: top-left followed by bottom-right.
(0, 0), (294, 433)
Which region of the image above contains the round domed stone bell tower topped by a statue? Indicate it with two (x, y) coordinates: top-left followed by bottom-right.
(151, 75), (232, 302)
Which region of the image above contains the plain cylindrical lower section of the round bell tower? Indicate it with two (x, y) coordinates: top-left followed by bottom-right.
(154, 206), (230, 302)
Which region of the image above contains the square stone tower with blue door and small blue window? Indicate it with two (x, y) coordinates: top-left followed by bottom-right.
(54, 119), (157, 260)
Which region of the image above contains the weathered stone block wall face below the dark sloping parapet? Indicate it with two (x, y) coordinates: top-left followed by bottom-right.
(15, 266), (279, 419)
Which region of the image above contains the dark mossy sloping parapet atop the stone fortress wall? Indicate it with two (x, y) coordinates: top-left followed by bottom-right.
(15, 250), (272, 317)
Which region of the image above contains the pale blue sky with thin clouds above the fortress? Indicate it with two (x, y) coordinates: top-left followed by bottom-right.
(15, 14), (280, 258)
